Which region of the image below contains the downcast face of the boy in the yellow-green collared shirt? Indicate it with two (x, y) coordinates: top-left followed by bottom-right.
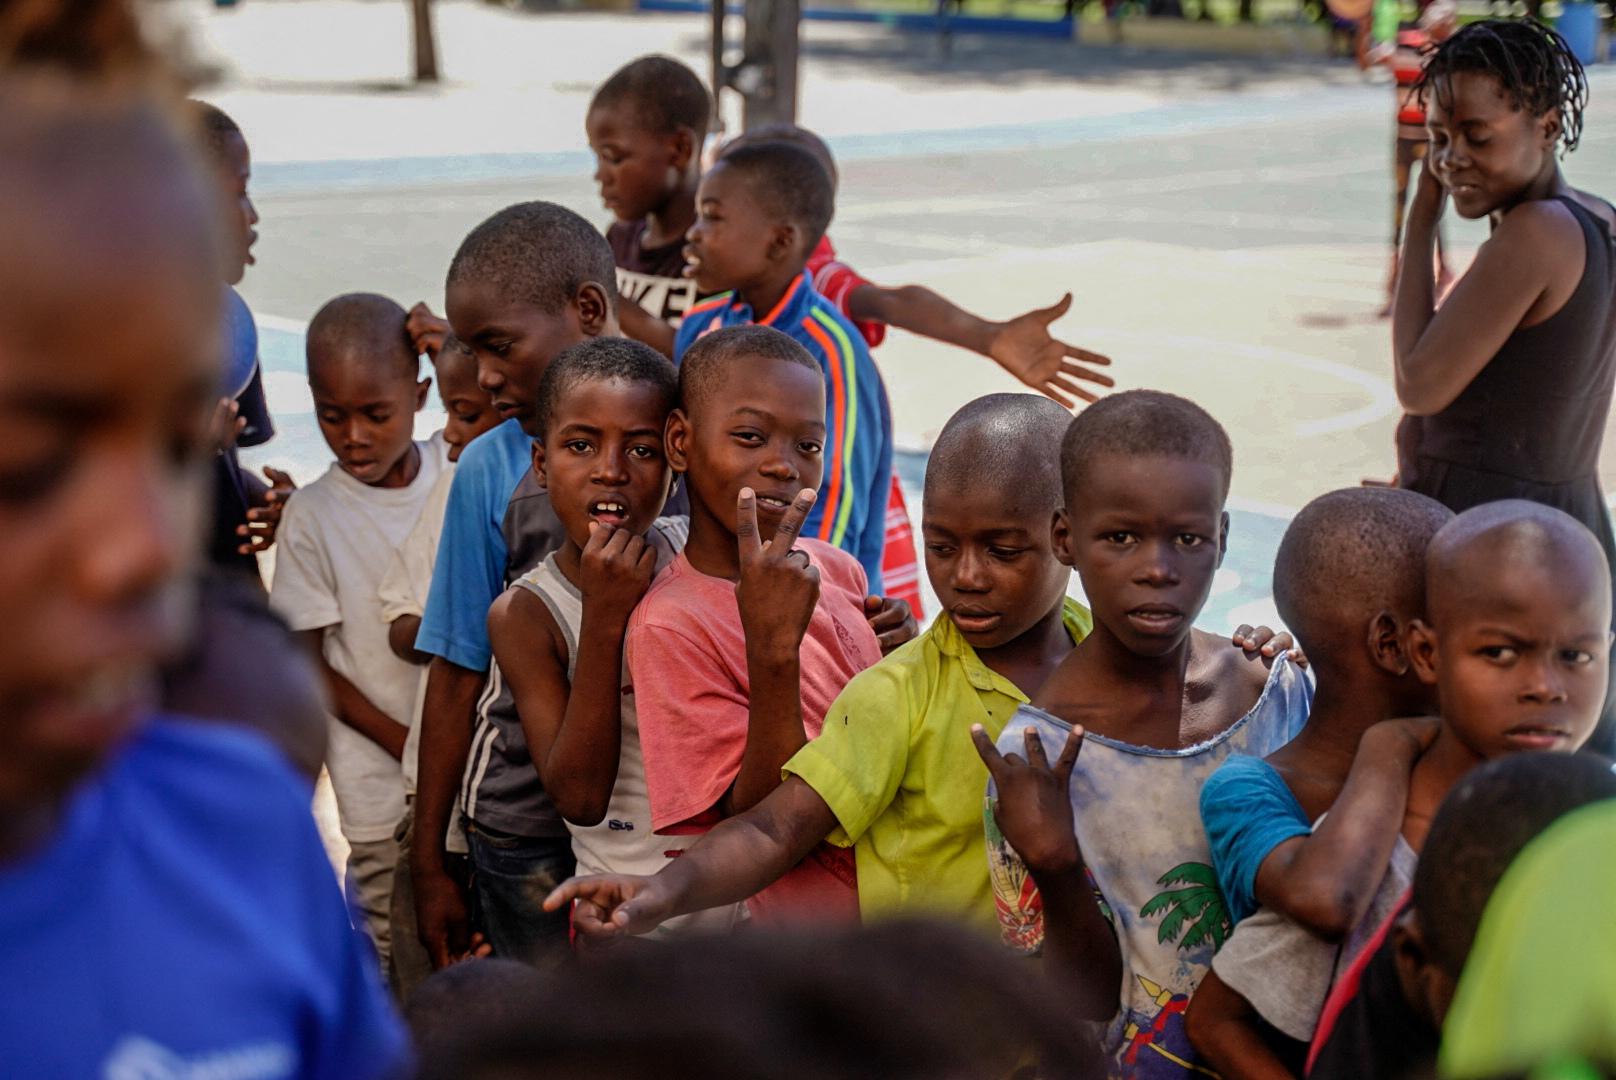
(921, 483), (1071, 648)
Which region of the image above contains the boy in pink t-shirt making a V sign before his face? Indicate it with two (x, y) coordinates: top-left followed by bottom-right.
(625, 325), (911, 922)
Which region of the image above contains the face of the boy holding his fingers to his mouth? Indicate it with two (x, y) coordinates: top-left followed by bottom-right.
(533, 378), (674, 548)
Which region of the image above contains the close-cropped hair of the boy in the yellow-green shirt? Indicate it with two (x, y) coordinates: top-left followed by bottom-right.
(926, 394), (1071, 514)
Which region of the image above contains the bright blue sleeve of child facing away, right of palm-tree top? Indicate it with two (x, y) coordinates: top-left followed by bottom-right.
(1201, 753), (1312, 923)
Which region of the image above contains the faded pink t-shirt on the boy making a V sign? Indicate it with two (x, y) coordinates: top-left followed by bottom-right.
(624, 538), (881, 922)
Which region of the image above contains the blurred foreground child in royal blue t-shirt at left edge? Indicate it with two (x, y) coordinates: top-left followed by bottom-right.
(0, 40), (407, 1080)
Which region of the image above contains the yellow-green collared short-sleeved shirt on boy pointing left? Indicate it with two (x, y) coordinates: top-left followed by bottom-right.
(784, 598), (1094, 934)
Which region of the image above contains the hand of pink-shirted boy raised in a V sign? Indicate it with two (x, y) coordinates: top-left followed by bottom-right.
(735, 488), (819, 661)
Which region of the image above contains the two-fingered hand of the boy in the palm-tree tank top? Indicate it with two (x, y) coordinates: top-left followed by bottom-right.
(971, 721), (1083, 876)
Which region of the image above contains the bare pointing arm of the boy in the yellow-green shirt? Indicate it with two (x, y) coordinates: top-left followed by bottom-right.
(545, 776), (837, 939)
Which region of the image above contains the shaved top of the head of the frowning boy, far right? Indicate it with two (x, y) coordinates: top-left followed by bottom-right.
(1425, 500), (1611, 629)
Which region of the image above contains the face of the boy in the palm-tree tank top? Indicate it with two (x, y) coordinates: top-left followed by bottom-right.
(1055, 454), (1228, 656)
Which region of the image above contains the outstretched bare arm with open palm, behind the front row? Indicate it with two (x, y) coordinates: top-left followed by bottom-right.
(847, 285), (1115, 409)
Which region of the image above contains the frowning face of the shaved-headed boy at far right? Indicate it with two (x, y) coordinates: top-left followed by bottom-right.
(1414, 546), (1610, 760)
